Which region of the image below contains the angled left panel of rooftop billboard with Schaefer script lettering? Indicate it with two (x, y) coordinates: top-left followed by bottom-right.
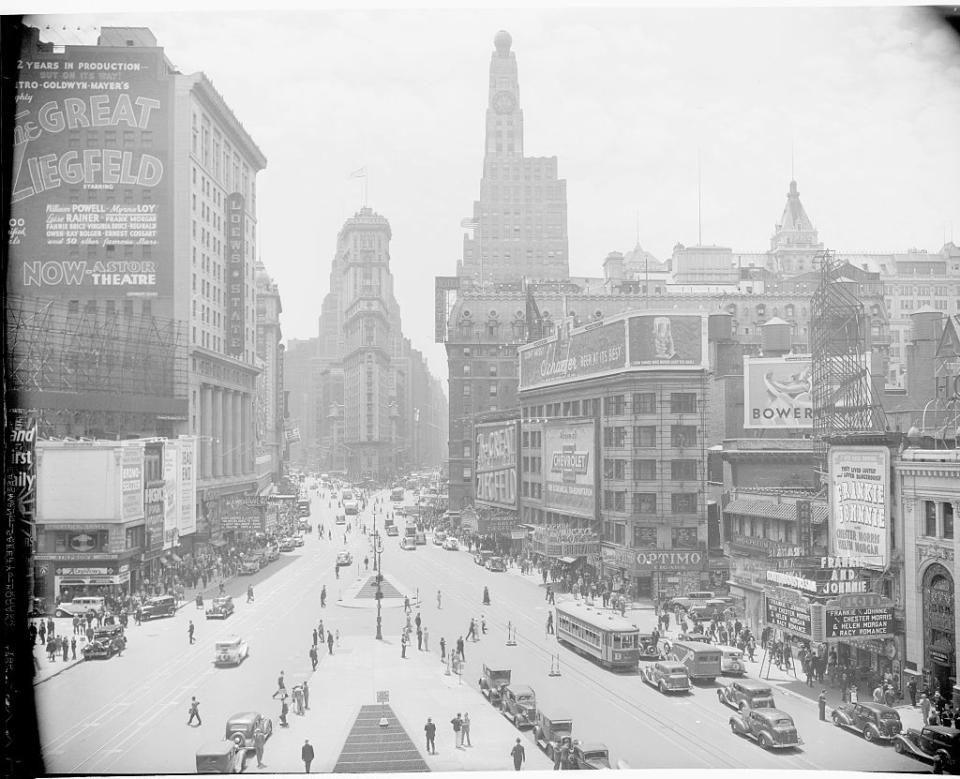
(520, 319), (627, 390)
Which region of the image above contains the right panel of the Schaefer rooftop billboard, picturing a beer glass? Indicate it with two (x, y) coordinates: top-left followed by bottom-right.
(629, 314), (708, 369)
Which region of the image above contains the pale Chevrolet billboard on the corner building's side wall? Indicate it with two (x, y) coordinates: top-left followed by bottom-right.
(543, 420), (597, 519)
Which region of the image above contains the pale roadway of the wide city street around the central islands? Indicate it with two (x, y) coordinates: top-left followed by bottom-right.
(36, 493), (924, 773)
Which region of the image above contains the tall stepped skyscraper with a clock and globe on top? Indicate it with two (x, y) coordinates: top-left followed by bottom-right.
(457, 30), (570, 284)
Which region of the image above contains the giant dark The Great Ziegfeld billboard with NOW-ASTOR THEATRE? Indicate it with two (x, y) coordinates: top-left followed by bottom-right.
(9, 35), (173, 298)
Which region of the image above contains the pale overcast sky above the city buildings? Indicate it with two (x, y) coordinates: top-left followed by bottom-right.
(20, 4), (960, 379)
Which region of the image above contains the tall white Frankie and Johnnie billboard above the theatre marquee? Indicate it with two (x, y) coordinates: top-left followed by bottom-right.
(829, 446), (890, 568)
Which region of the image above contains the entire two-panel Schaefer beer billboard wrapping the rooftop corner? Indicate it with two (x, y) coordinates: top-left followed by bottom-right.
(520, 313), (708, 391)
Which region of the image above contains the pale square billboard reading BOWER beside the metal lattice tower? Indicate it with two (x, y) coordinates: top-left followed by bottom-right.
(743, 354), (813, 430)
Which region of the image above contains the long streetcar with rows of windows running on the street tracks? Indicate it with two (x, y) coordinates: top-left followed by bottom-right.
(556, 601), (640, 670)
